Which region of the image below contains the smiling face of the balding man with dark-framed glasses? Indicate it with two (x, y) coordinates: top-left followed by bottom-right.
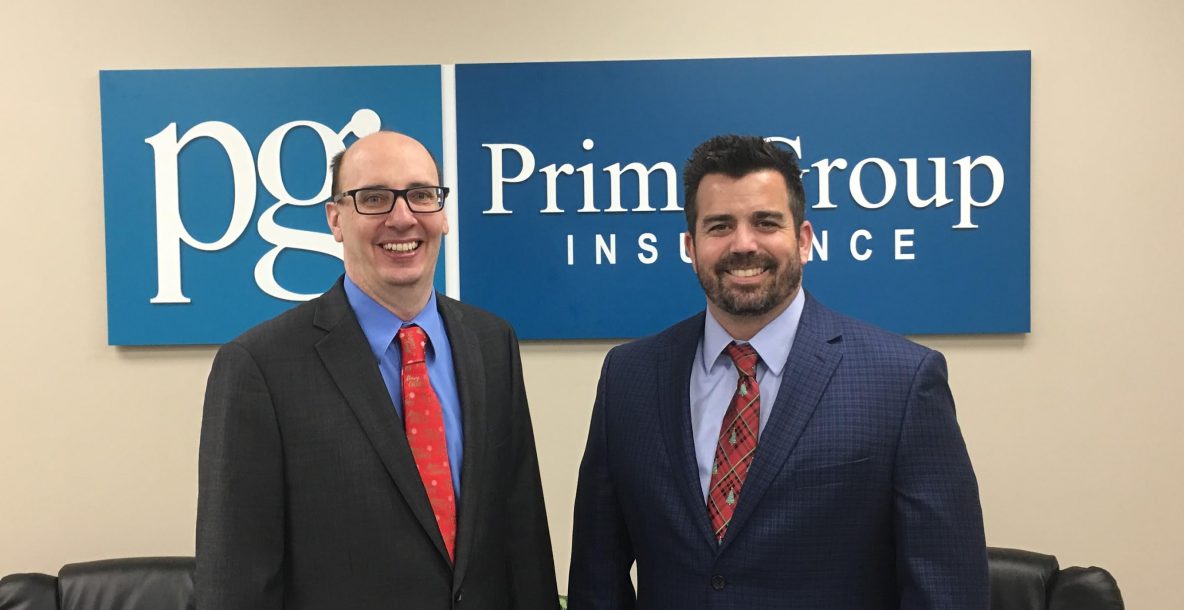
(324, 131), (448, 319)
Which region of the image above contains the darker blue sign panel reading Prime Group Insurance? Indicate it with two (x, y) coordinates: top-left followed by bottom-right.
(456, 52), (1031, 339)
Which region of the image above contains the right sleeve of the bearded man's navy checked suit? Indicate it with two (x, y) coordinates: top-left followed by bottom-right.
(894, 352), (989, 610)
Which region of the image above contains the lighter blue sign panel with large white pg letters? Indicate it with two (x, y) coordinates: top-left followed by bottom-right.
(99, 66), (443, 345)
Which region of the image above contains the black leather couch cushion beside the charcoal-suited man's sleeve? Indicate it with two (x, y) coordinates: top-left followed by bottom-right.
(58, 557), (195, 610)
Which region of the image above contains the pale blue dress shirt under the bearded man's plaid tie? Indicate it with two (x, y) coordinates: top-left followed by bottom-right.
(690, 288), (805, 502)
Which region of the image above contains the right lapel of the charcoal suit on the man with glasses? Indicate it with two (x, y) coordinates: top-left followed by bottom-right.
(438, 295), (489, 586)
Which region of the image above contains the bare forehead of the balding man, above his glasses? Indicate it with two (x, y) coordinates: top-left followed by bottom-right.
(341, 133), (439, 190)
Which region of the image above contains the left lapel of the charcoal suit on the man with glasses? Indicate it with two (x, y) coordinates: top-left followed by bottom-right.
(313, 281), (452, 561)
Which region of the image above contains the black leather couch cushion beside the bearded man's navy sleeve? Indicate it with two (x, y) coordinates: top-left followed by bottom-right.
(986, 547), (1058, 610)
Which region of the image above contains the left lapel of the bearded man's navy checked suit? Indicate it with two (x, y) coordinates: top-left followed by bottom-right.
(656, 314), (716, 546)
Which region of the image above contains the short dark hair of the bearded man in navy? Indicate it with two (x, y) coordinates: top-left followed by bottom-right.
(682, 134), (806, 236)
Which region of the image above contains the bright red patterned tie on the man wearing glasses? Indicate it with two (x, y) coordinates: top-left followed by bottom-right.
(399, 325), (456, 560)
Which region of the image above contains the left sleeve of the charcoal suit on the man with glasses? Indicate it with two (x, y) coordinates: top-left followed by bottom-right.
(195, 343), (284, 610)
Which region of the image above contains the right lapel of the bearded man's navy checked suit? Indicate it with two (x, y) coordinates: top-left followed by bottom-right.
(720, 294), (843, 551)
